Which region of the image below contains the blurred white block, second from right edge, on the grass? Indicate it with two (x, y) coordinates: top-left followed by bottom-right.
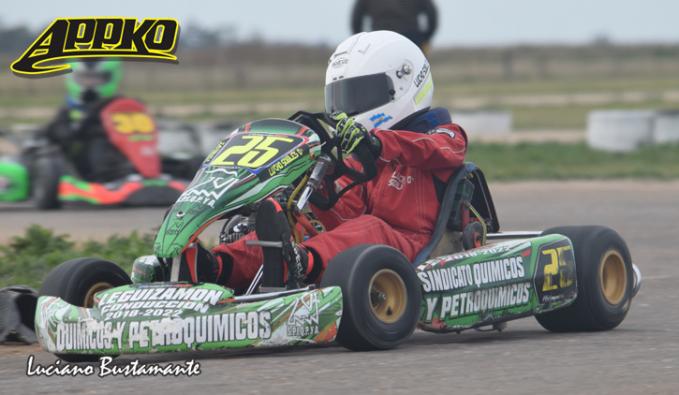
(587, 110), (655, 152)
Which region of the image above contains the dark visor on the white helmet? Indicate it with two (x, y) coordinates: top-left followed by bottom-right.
(325, 73), (394, 115)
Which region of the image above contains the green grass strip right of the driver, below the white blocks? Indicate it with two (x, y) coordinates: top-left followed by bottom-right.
(467, 143), (679, 180)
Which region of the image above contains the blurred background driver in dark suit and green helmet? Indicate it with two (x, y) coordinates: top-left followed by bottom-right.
(36, 60), (132, 181)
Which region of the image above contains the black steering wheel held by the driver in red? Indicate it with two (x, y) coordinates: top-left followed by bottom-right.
(289, 111), (377, 210)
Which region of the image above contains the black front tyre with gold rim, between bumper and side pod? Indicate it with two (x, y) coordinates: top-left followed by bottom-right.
(321, 244), (422, 351)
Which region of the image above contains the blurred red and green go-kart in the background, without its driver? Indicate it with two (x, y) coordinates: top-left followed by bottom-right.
(0, 98), (202, 209)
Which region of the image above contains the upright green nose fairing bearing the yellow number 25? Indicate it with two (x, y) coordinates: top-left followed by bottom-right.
(154, 119), (320, 258)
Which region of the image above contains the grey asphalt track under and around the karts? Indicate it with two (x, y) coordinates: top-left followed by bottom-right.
(0, 181), (679, 395)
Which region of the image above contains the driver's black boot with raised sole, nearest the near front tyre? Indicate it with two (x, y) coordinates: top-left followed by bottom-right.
(255, 198), (313, 291)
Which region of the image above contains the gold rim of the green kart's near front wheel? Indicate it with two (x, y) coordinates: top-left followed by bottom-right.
(369, 269), (408, 324)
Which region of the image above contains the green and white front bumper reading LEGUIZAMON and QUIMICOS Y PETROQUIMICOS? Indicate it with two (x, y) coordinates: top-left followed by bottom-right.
(35, 283), (342, 355)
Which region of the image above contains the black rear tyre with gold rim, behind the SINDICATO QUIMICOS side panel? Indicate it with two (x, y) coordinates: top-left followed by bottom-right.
(535, 226), (634, 332)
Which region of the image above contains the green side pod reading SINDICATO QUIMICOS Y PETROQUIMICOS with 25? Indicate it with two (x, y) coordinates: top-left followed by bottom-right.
(417, 235), (577, 331)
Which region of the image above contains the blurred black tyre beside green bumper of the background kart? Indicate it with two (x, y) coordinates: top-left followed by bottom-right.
(31, 153), (64, 210)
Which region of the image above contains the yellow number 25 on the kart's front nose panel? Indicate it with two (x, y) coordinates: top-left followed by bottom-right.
(210, 134), (299, 169)
